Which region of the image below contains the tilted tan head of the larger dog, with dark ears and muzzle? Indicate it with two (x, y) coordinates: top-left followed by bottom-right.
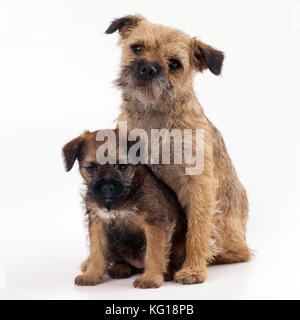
(106, 16), (224, 107)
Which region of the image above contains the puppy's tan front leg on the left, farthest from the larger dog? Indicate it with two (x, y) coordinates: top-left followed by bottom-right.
(75, 216), (107, 286)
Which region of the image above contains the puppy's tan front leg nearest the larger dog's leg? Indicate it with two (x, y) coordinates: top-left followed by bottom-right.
(133, 225), (169, 289)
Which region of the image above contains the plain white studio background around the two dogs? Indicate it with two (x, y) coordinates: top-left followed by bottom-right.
(0, 0), (300, 299)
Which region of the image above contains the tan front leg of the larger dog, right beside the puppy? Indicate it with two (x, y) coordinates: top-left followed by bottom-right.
(174, 176), (215, 284)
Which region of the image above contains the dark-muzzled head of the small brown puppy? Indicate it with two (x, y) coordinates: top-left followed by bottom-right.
(63, 130), (137, 211)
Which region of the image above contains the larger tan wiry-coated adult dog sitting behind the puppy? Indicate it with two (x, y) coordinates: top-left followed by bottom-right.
(106, 16), (251, 284)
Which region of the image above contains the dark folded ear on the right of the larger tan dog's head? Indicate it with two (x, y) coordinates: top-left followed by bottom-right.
(193, 38), (224, 75)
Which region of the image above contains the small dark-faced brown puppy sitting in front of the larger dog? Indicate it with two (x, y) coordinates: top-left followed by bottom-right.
(63, 130), (186, 288)
